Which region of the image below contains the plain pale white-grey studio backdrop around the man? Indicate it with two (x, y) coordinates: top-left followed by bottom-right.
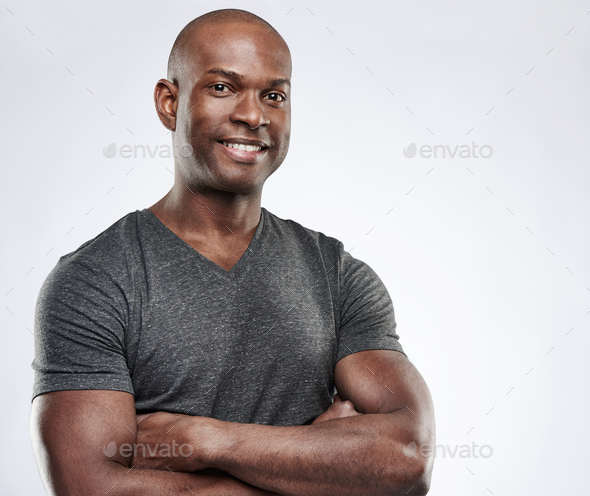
(0, 0), (590, 496)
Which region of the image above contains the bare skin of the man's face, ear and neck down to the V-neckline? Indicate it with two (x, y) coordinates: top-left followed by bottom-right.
(150, 23), (291, 270)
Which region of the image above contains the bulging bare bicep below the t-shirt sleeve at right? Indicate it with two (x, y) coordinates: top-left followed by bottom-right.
(334, 350), (434, 430)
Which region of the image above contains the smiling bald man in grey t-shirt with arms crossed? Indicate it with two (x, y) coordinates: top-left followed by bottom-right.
(32, 10), (434, 496)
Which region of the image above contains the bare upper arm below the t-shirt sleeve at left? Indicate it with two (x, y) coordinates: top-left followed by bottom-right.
(31, 390), (136, 495)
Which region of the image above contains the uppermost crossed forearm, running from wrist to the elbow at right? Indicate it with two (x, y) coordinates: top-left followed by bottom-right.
(206, 412), (430, 496)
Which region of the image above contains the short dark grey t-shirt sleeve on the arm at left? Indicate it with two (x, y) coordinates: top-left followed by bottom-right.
(32, 257), (133, 398)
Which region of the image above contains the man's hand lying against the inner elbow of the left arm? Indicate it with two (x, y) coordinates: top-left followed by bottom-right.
(133, 412), (211, 472)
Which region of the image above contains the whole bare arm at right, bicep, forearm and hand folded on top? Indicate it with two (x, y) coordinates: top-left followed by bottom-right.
(136, 350), (434, 495)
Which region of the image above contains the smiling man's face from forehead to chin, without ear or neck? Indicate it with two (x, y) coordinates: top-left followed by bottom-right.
(175, 23), (291, 193)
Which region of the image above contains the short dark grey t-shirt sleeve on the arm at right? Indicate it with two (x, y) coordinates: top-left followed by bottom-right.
(336, 242), (405, 361)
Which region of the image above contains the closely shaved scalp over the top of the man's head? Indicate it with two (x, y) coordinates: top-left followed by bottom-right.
(167, 9), (289, 85)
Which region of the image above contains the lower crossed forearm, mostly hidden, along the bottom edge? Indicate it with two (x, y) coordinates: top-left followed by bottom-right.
(103, 465), (276, 496)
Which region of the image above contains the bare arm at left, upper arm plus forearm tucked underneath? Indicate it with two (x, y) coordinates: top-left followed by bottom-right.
(31, 390), (280, 496)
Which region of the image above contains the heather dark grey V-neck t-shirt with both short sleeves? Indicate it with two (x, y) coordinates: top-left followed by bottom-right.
(33, 208), (403, 425)
